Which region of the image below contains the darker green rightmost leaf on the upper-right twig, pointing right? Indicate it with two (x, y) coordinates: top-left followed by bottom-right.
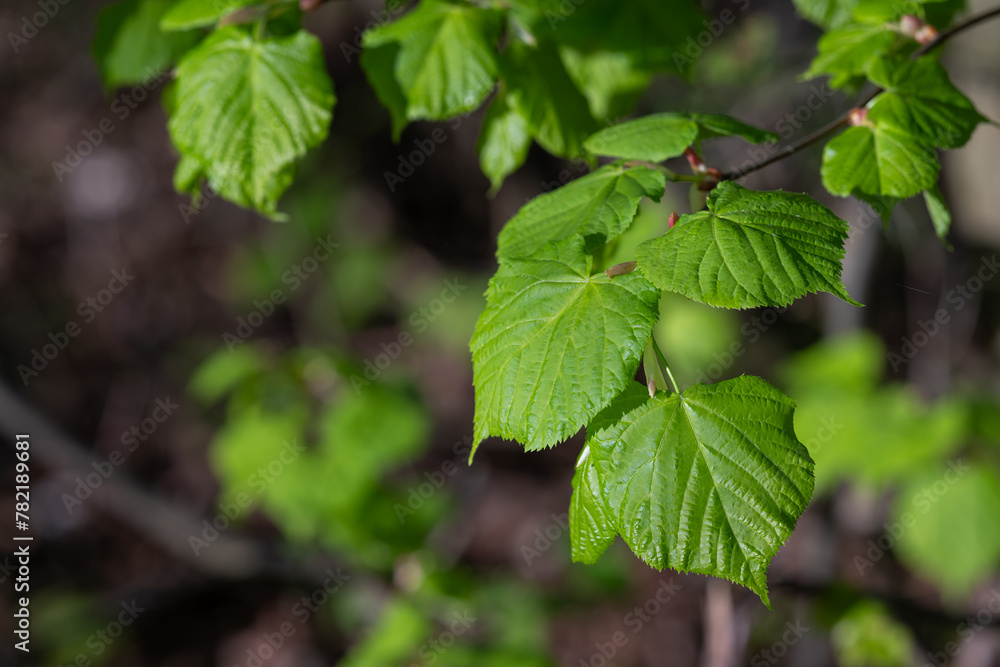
(868, 57), (986, 148)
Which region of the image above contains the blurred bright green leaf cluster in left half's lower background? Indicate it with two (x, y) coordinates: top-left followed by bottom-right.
(191, 344), (431, 569)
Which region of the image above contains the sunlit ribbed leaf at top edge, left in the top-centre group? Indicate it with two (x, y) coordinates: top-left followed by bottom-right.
(364, 0), (503, 120)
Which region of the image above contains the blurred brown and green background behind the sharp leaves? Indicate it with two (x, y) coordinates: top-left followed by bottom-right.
(0, 0), (1000, 667)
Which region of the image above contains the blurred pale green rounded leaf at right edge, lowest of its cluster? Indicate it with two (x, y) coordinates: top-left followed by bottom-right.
(894, 461), (1000, 596)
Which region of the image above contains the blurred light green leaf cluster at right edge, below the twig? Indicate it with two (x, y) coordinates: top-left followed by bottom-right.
(783, 334), (1000, 597)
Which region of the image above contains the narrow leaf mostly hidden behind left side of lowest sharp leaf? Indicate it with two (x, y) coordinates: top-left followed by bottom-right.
(569, 382), (649, 565)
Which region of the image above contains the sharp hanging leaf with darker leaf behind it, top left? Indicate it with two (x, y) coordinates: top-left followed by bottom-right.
(94, 0), (336, 217)
